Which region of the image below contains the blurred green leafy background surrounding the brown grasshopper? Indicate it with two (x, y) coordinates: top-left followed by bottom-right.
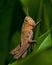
(0, 0), (52, 65)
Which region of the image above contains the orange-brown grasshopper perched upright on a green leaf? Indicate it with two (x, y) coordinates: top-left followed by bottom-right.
(10, 9), (40, 59)
